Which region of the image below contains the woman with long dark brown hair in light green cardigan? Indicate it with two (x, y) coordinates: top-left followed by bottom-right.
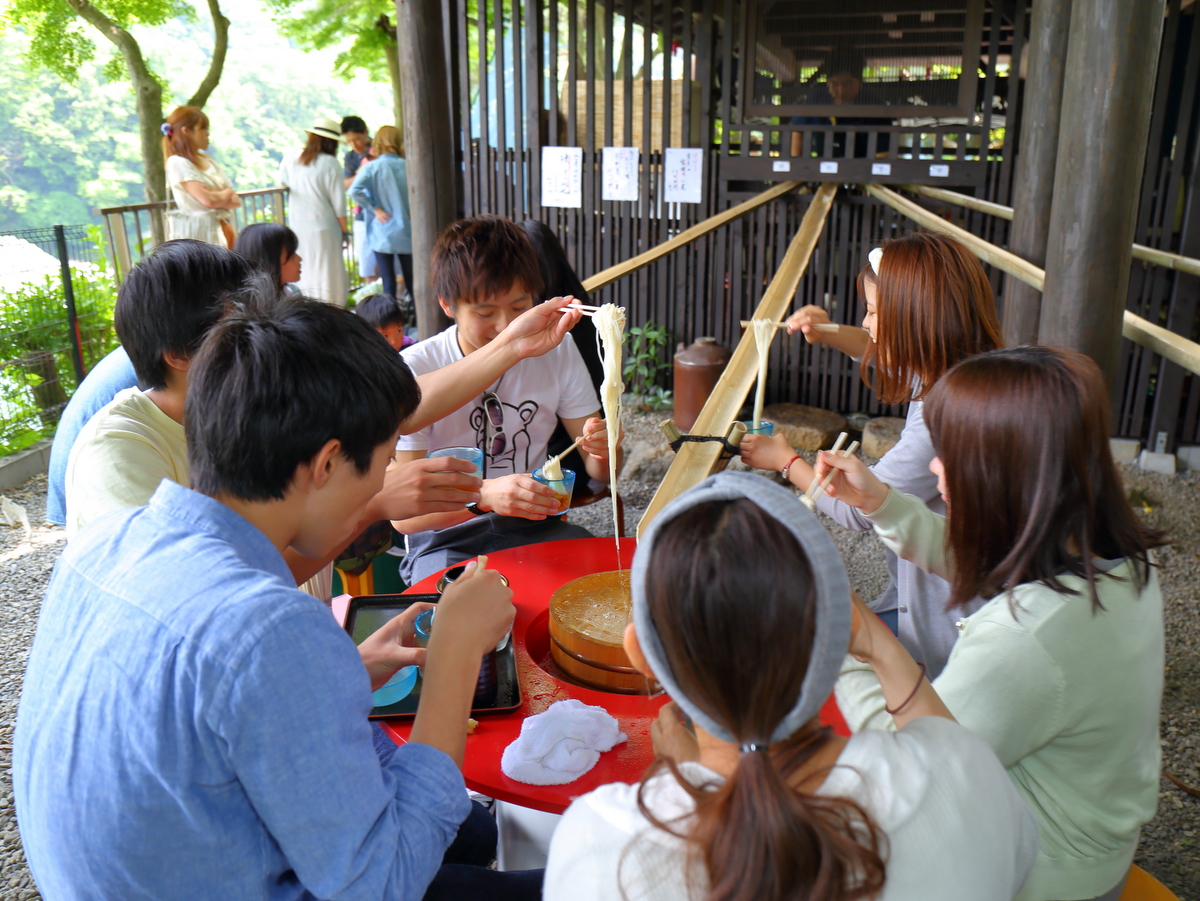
(818, 347), (1163, 901)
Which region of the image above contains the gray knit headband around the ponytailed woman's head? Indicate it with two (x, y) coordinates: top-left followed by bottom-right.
(630, 473), (851, 744)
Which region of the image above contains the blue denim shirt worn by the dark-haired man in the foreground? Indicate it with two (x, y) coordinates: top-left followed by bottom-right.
(13, 482), (470, 901)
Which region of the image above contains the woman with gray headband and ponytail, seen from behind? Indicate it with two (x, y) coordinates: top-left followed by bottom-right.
(544, 473), (1037, 901)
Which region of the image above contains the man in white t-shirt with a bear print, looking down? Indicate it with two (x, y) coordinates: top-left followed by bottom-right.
(392, 216), (620, 584)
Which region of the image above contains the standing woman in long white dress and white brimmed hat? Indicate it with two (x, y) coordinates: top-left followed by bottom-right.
(278, 119), (350, 306)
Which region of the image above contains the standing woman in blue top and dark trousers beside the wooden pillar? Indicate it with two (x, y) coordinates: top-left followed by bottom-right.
(350, 125), (413, 298)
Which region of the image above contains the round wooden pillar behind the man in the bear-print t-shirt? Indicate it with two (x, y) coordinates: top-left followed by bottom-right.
(396, 0), (456, 338)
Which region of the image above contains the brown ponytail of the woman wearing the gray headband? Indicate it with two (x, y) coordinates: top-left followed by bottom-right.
(637, 723), (886, 901)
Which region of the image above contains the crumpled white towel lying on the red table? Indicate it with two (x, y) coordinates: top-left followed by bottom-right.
(500, 698), (626, 786)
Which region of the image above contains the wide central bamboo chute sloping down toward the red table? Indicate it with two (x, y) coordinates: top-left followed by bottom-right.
(637, 184), (838, 535)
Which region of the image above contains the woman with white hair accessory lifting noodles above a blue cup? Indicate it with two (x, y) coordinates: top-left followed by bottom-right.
(742, 232), (1003, 675)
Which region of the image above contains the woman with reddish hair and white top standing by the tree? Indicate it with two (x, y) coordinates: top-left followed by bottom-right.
(162, 107), (241, 247)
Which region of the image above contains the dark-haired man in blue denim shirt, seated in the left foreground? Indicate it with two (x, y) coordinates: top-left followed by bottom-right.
(13, 301), (540, 901)
